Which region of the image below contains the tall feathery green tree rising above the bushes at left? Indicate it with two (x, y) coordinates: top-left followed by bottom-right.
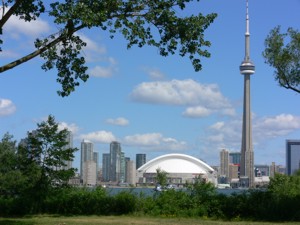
(19, 115), (77, 209)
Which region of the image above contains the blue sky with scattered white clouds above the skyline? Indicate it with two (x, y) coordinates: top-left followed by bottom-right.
(0, 0), (300, 168)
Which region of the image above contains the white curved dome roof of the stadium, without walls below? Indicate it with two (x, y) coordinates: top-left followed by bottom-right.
(138, 154), (214, 174)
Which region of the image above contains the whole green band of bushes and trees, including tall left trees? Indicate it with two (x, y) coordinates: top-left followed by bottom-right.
(0, 116), (300, 221)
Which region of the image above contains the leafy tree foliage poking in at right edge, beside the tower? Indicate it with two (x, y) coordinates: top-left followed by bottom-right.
(263, 26), (300, 93)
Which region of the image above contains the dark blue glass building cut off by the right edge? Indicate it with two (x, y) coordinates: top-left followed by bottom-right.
(286, 140), (300, 175)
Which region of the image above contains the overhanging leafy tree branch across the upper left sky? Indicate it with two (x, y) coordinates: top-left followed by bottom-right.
(0, 0), (217, 97)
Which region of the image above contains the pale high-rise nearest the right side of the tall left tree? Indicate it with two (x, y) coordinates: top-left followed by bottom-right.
(80, 140), (98, 185)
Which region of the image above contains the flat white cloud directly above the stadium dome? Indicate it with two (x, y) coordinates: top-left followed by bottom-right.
(124, 133), (187, 151)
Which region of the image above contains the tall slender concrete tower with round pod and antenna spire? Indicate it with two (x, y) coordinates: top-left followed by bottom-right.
(240, 0), (255, 187)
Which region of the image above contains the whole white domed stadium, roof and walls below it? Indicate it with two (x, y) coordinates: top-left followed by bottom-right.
(137, 154), (217, 185)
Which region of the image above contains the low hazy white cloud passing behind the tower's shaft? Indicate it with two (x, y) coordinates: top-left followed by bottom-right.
(200, 114), (300, 160)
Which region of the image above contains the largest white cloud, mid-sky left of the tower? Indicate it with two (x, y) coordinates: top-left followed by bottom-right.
(130, 79), (235, 117)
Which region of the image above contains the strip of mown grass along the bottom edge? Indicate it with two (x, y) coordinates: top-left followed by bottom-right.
(0, 216), (300, 225)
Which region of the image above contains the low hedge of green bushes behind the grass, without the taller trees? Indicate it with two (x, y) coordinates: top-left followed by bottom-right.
(0, 179), (300, 222)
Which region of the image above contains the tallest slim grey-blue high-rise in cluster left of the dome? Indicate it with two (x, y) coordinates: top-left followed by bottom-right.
(110, 141), (122, 182)
